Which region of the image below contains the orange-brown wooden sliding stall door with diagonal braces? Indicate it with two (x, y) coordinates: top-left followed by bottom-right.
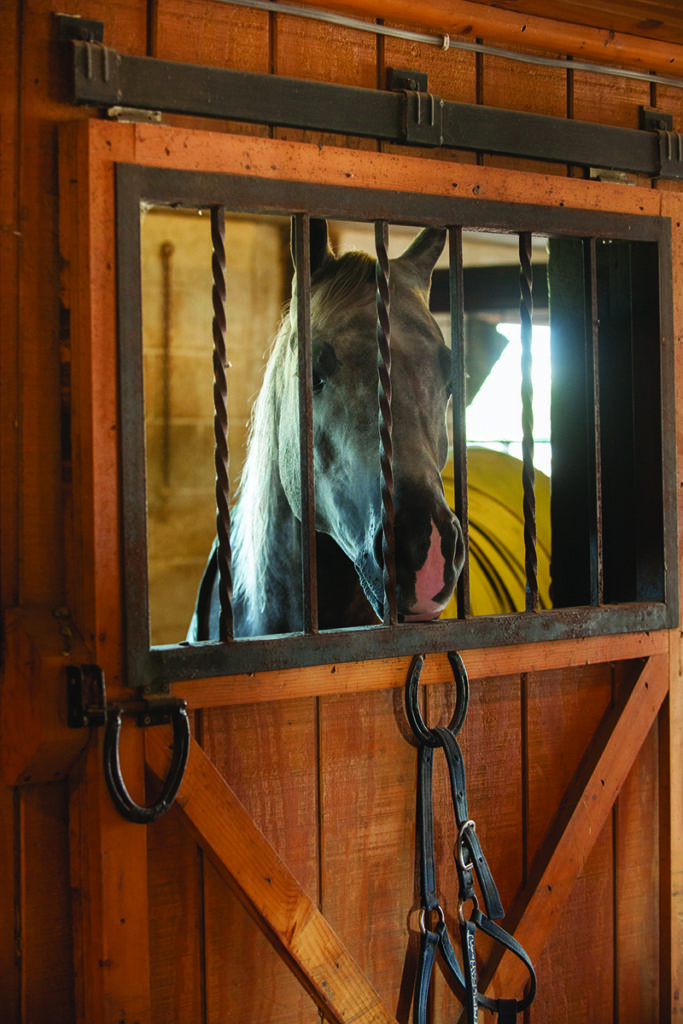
(53, 121), (680, 1024)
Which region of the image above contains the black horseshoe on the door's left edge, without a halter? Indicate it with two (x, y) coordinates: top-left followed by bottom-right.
(103, 701), (189, 825)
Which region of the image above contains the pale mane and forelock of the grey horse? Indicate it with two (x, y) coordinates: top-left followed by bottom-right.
(231, 251), (375, 613)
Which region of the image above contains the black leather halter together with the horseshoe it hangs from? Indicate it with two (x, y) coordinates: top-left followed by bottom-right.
(405, 652), (536, 1024)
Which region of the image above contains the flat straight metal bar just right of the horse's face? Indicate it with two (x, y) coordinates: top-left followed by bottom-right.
(449, 227), (470, 618)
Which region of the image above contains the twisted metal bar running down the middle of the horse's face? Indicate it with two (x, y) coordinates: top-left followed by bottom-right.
(375, 220), (398, 626)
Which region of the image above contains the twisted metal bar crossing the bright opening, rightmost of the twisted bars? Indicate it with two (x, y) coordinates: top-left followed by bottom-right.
(519, 231), (539, 611)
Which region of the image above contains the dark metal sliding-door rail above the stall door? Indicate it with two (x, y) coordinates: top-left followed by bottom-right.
(73, 41), (683, 180)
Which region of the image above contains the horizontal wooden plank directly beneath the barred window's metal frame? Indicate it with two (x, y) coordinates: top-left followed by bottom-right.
(173, 632), (669, 708)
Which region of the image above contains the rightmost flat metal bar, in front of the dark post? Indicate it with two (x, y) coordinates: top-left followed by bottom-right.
(584, 239), (604, 606)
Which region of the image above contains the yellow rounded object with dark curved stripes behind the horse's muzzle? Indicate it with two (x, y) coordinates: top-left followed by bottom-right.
(441, 447), (551, 618)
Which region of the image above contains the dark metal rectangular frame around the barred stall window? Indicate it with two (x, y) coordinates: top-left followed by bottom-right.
(116, 164), (678, 692)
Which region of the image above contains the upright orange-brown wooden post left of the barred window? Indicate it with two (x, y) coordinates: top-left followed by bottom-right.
(59, 117), (134, 679)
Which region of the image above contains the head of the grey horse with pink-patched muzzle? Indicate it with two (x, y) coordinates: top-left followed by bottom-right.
(279, 220), (464, 621)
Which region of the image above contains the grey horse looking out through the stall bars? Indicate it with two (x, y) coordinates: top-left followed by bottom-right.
(187, 218), (465, 642)
